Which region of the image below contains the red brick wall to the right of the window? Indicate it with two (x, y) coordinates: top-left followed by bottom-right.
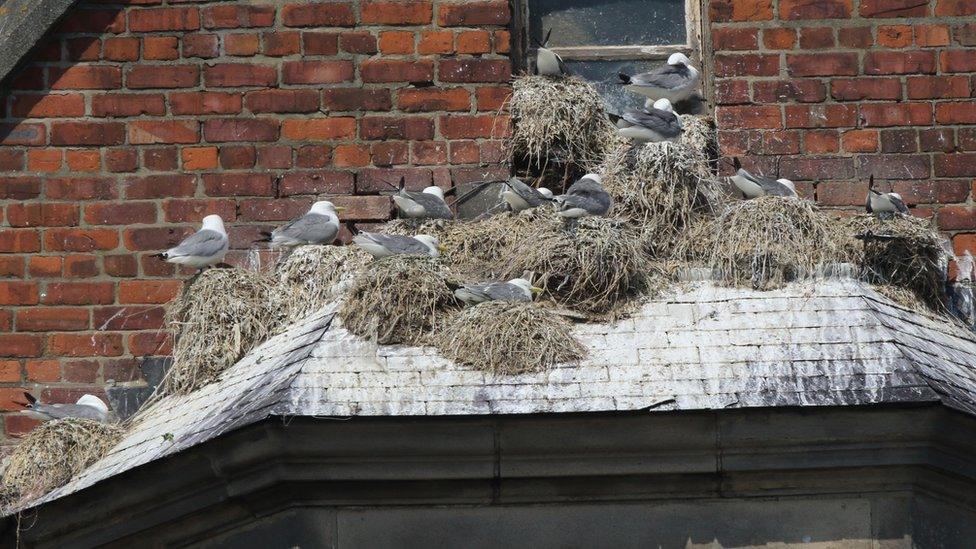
(708, 0), (976, 252)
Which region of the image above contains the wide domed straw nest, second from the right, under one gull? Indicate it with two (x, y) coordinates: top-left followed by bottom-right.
(679, 196), (845, 290)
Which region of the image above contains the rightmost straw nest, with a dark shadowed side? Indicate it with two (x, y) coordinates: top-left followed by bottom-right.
(834, 214), (949, 311)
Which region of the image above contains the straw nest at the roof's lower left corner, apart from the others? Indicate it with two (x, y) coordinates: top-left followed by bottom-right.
(0, 419), (123, 509)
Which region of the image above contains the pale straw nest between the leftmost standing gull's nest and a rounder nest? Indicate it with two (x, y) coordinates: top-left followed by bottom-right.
(271, 246), (369, 323)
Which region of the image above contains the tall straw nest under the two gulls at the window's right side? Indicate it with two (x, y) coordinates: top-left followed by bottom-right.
(597, 115), (720, 257)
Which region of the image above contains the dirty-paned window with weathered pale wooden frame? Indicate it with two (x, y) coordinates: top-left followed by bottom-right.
(516, 0), (701, 109)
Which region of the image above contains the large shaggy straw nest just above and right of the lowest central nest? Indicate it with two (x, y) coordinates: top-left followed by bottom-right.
(496, 217), (656, 315)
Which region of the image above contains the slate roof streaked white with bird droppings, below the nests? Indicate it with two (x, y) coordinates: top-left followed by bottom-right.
(22, 279), (976, 510)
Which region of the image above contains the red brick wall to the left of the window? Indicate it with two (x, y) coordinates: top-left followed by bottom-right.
(0, 0), (510, 436)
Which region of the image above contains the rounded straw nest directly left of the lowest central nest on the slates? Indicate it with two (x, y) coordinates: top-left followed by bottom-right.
(339, 255), (457, 345)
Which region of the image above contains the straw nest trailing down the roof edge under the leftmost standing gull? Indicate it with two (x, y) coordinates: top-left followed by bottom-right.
(165, 269), (281, 394)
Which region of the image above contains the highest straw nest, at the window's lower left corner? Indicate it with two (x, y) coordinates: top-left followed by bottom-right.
(509, 75), (616, 182)
